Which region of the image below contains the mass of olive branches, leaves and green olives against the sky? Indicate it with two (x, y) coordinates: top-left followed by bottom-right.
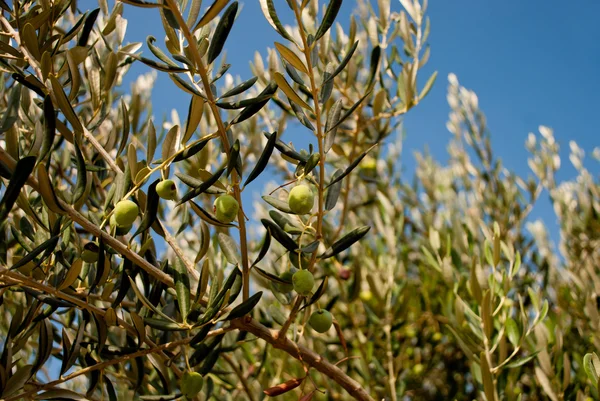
(0, 0), (600, 401)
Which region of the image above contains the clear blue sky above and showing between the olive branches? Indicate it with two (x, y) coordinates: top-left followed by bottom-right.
(124, 0), (600, 239)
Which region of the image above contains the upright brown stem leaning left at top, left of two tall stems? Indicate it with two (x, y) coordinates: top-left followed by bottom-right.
(166, 0), (250, 300)
